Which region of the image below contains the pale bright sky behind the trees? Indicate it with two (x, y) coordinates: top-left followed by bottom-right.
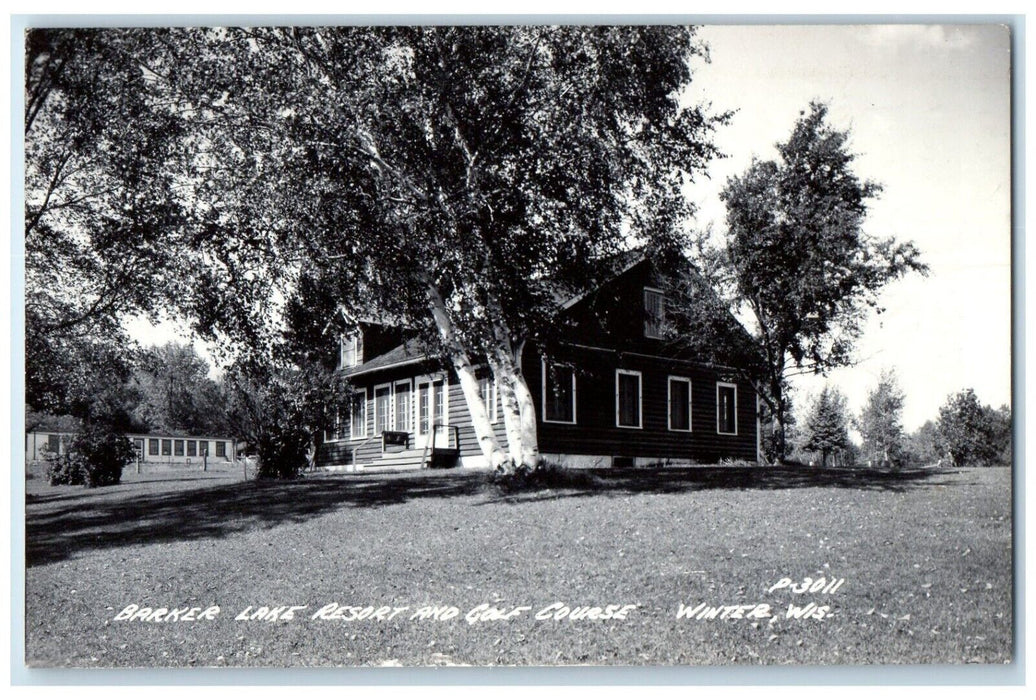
(123, 25), (1011, 430)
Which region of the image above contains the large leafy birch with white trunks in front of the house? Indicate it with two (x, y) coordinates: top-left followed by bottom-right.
(89, 27), (729, 464)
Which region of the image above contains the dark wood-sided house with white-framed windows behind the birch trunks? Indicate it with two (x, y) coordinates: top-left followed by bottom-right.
(318, 251), (759, 470)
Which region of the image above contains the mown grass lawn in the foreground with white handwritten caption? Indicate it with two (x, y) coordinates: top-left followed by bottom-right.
(26, 467), (1012, 667)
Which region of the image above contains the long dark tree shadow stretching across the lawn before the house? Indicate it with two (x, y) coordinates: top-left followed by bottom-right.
(26, 467), (960, 566)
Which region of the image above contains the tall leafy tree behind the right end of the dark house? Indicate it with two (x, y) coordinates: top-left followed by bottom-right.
(707, 103), (927, 457)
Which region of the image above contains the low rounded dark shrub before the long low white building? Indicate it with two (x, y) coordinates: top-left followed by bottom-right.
(47, 426), (136, 489)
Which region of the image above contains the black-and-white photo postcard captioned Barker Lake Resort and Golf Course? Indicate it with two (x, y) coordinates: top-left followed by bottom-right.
(11, 17), (1021, 670)
